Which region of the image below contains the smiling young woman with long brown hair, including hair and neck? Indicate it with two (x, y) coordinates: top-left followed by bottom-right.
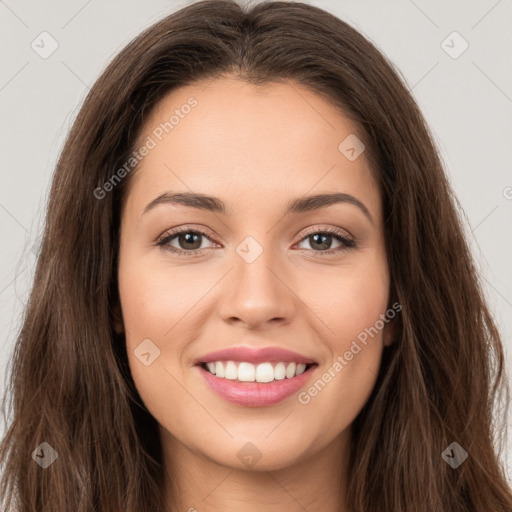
(1, 0), (512, 512)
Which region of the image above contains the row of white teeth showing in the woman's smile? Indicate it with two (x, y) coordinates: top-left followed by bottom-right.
(201, 361), (312, 383)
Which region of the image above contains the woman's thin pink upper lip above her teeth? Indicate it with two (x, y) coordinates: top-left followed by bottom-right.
(194, 346), (316, 365)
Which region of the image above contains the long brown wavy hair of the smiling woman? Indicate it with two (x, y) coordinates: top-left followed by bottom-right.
(0, 0), (512, 512)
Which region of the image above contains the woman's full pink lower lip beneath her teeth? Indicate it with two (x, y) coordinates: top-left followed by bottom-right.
(197, 365), (317, 407)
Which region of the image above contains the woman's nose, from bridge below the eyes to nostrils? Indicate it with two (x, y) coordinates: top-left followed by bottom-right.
(218, 242), (299, 330)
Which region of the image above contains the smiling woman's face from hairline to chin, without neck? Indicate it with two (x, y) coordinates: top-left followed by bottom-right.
(117, 78), (389, 469)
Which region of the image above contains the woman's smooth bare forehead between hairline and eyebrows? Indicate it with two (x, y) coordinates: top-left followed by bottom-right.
(123, 78), (379, 218)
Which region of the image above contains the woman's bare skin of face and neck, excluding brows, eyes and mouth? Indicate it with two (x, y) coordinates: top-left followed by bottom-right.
(116, 77), (391, 512)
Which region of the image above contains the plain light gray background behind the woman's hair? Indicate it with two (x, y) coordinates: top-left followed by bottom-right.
(0, 0), (512, 480)
